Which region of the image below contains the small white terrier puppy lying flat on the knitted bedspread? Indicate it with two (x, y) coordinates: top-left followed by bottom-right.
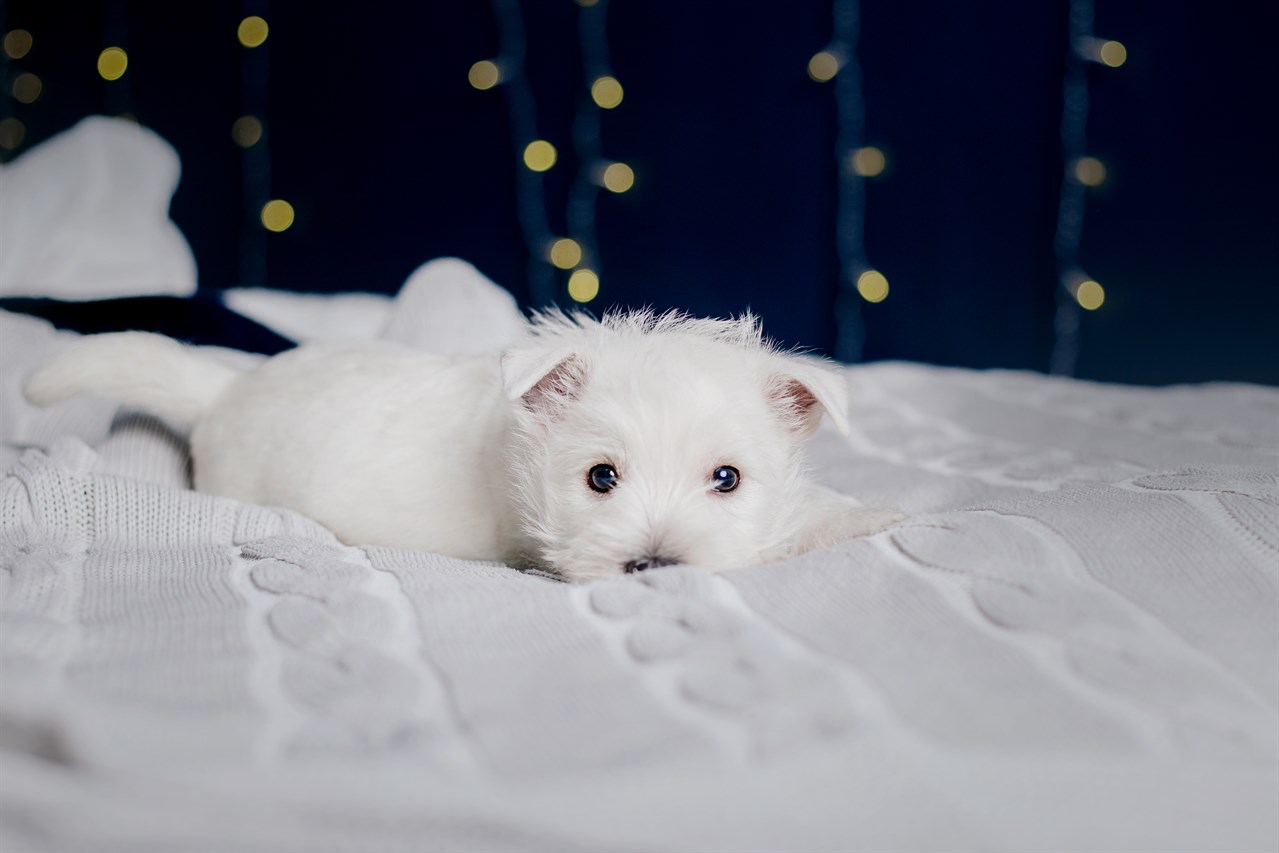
(24, 306), (900, 581)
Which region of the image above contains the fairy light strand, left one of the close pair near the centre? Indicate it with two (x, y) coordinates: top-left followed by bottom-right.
(483, 0), (556, 307)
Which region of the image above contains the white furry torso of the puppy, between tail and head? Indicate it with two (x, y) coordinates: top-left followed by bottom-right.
(191, 344), (518, 560)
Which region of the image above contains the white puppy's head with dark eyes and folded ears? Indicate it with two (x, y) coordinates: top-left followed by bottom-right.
(503, 312), (847, 581)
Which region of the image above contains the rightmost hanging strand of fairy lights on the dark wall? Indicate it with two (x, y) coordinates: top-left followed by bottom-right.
(1049, 0), (1128, 376)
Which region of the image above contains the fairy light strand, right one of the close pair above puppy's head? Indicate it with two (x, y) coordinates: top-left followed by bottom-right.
(567, 0), (614, 302)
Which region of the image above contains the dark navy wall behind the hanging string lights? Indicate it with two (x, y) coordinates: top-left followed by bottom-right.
(0, 0), (1279, 384)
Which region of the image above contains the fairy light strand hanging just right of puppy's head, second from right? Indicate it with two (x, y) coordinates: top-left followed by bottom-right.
(828, 0), (871, 362)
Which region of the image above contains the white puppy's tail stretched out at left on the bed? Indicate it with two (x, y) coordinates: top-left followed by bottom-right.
(22, 331), (240, 425)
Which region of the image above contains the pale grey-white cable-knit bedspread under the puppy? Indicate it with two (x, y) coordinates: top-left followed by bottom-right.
(0, 308), (1279, 853)
